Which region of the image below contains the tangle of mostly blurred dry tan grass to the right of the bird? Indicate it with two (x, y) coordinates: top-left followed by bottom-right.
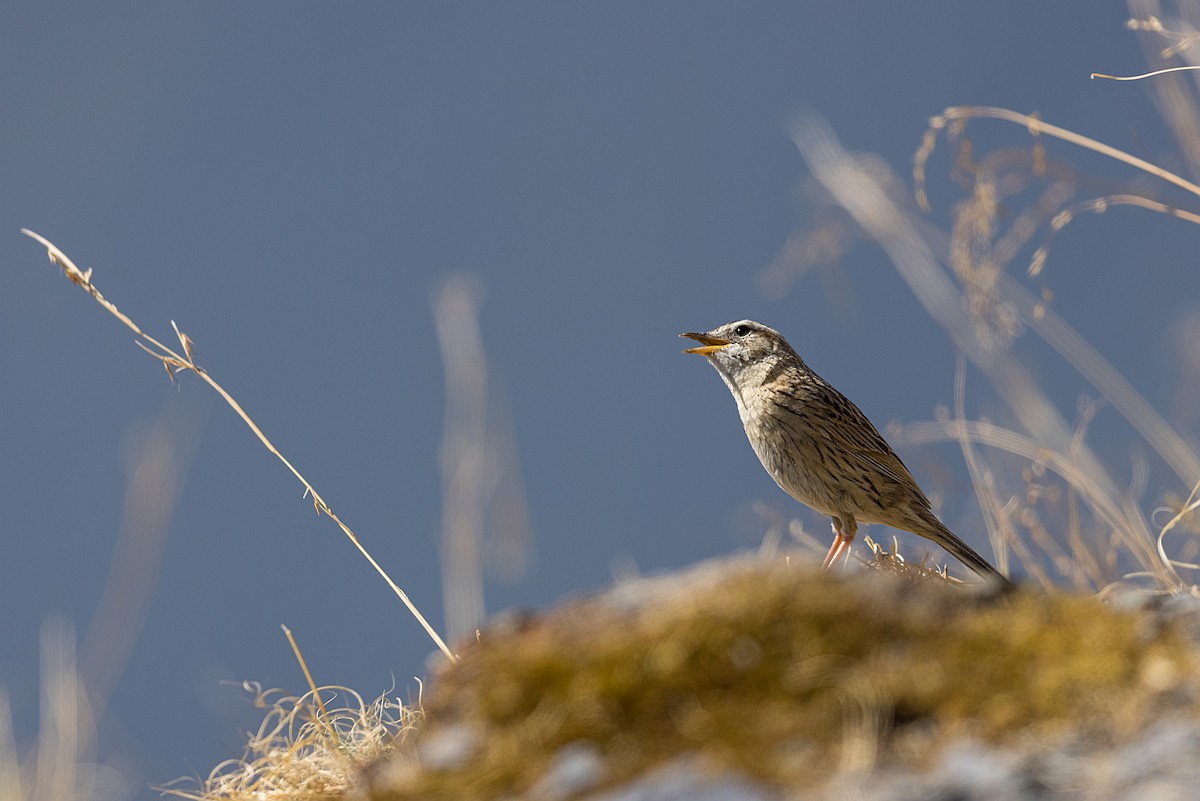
(756, 2), (1200, 592)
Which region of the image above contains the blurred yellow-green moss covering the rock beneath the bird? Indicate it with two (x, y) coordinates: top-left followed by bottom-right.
(376, 562), (1195, 800)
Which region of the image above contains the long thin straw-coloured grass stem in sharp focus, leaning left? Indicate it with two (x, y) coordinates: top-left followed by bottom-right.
(22, 228), (456, 661)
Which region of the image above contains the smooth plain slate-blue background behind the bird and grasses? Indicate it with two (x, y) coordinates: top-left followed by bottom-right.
(0, 1), (1200, 797)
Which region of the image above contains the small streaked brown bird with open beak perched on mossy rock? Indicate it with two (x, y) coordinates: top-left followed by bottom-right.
(679, 320), (1009, 586)
